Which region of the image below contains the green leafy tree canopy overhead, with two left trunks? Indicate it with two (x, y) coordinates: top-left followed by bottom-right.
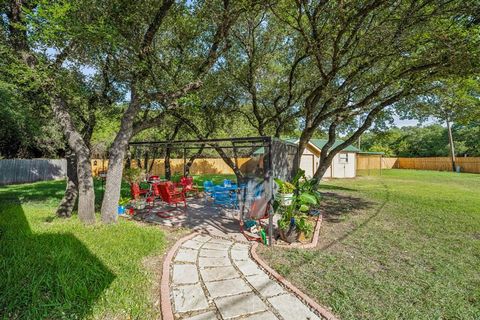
(0, 0), (480, 222)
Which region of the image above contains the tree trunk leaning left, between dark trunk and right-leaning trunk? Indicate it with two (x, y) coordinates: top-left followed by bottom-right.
(50, 96), (95, 224)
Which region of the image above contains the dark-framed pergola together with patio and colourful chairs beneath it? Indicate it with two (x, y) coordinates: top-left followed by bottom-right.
(121, 137), (294, 244)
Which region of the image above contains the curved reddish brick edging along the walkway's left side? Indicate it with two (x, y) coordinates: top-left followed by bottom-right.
(160, 232), (199, 320)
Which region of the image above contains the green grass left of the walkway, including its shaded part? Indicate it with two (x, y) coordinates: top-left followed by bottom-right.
(0, 181), (175, 319)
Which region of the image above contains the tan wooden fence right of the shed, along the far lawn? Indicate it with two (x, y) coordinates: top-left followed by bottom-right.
(357, 155), (480, 173)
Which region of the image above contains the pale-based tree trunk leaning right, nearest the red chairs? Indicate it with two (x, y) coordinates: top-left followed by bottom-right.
(102, 89), (139, 223)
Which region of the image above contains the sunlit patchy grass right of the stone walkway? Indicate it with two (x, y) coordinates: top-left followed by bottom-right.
(262, 170), (480, 319)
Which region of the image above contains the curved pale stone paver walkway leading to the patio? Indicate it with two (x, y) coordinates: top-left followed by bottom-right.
(170, 235), (321, 320)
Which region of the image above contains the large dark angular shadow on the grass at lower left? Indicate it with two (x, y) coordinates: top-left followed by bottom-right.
(0, 197), (115, 319)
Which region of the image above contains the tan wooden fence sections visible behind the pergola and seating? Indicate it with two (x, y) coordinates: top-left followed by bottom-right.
(92, 158), (258, 176)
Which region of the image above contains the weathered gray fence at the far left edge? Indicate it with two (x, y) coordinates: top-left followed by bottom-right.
(0, 159), (67, 185)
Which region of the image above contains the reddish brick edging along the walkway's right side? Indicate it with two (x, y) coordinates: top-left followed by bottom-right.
(250, 242), (339, 320)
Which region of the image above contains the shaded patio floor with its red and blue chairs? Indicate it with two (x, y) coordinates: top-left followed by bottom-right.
(127, 178), (278, 241)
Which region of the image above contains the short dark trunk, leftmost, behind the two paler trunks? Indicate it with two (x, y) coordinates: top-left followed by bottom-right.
(57, 149), (78, 218)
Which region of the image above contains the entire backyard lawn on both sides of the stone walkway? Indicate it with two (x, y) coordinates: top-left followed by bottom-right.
(0, 170), (480, 319)
